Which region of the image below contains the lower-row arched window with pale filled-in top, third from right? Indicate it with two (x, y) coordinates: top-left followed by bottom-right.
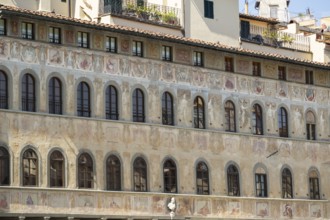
(253, 163), (269, 197)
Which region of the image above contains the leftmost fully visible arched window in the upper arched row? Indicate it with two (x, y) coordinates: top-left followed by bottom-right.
(22, 73), (36, 112)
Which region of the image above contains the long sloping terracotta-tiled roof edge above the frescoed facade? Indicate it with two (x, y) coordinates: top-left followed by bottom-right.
(0, 5), (330, 70)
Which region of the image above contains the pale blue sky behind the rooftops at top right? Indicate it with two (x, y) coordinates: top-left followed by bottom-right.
(239, 0), (330, 20)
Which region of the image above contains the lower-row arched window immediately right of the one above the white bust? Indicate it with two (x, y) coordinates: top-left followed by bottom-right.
(196, 162), (210, 195)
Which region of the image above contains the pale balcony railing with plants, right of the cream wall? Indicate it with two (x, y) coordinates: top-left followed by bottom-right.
(241, 25), (310, 52)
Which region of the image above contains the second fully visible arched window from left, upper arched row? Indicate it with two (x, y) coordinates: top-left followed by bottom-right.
(48, 77), (62, 115)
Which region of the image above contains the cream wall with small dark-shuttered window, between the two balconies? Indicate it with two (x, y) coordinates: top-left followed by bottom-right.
(184, 0), (240, 47)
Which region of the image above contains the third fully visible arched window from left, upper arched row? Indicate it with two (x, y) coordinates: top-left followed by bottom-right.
(77, 82), (91, 117)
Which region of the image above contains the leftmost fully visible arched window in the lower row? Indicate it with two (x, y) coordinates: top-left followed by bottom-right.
(21, 148), (39, 187)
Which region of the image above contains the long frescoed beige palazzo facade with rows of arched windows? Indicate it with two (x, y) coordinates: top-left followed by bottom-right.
(0, 1), (330, 220)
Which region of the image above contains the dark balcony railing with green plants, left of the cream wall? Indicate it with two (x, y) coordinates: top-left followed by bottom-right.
(104, 0), (180, 26)
